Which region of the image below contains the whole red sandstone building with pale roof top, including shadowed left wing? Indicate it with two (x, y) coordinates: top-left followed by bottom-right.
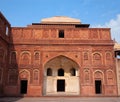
(0, 13), (118, 96)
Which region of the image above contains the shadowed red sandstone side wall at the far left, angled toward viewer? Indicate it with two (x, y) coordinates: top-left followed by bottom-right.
(0, 12), (10, 96)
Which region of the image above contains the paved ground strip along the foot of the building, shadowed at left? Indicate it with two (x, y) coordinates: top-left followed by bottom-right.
(0, 97), (120, 102)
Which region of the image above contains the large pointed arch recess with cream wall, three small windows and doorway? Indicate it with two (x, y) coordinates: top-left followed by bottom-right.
(43, 56), (80, 95)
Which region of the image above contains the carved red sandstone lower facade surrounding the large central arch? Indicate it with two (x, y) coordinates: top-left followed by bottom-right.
(5, 44), (117, 96)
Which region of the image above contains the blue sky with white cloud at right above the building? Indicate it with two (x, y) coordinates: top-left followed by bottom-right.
(0, 0), (120, 43)
